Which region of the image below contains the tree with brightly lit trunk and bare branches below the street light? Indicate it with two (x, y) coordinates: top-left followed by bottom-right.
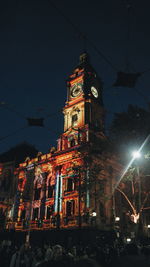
(115, 166), (150, 238)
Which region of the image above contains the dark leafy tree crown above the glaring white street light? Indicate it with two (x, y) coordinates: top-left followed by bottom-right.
(109, 105), (150, 161)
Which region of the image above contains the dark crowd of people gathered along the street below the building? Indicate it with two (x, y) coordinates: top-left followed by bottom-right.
(0, 236), (150, 267)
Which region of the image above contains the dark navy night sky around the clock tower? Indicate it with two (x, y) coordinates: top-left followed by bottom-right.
(0, 0), (150, 153)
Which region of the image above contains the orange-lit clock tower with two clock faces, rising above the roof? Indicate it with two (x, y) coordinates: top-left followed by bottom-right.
(64, 53), (104, 140)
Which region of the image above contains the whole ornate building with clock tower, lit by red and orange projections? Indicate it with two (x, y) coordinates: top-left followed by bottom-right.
(7, 53), (120, 230)
